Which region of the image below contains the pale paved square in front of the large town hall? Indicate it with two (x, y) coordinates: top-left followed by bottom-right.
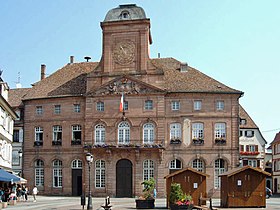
(2, 196), (280, 210)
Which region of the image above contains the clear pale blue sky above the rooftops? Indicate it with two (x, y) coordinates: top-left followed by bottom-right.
(0, 0), (280, 143)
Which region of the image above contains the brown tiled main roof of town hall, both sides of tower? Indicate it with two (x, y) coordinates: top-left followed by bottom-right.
(20, 58), (243, 100)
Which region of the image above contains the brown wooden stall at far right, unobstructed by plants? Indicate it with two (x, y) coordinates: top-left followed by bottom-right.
(220, 166), (271, 207)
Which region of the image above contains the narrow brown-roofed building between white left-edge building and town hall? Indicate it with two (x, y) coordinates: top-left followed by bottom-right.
(8, 88), (30, 177)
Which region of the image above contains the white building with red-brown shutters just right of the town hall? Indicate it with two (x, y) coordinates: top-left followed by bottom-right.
(239, 106), (267, 170)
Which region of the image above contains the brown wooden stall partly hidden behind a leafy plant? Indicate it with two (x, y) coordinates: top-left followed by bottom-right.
(164, 168), (209, 207)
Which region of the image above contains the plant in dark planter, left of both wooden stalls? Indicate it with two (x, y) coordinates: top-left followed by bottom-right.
(135, 178), (156, 209)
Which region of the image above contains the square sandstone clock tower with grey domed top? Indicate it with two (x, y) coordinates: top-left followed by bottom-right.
(100, 4), (152, 76)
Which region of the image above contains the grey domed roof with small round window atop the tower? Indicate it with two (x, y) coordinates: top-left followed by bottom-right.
(104, 4), (146, 22)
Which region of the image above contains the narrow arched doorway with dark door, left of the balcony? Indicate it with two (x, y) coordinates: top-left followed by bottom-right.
(71, 160), (83, 196)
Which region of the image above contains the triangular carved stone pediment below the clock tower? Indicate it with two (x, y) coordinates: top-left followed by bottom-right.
(88, 77), (164, 95)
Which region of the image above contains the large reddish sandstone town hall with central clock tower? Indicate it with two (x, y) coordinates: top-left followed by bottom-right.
(9, 5), (243, 197)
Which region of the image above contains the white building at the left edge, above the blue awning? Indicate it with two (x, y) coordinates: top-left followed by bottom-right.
(0, 75), (16, 172)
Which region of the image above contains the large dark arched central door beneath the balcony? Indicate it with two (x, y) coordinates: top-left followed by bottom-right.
(116, 159), (132, 198)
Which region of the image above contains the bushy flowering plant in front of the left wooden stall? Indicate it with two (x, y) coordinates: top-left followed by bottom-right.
(169, 183), (193, 210)
